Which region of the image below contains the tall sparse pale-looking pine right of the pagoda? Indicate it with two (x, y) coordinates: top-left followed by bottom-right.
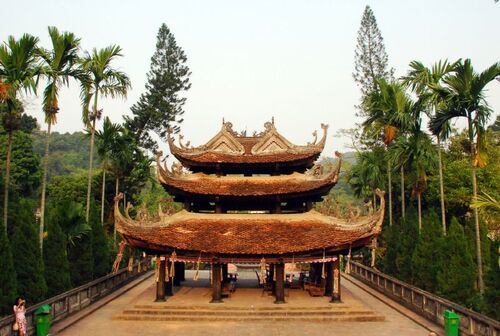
(352, 6), (394, 115)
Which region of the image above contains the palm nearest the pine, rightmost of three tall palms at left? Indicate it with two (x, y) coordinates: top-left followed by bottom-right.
(81, 45), (130, 222)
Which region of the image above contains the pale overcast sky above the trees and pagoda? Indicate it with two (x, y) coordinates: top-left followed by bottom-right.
(0, 0), (500, 155)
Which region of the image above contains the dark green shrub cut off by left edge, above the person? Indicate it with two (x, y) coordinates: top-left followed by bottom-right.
(0, 222), (17, 316)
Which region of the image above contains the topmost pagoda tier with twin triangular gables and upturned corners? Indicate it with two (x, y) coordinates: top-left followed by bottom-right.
(168, 121), (328, 174)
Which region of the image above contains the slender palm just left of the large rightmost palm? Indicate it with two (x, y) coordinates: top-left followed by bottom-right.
(402, 60), (458, 236)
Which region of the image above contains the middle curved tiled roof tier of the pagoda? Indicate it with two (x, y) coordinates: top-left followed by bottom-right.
(156, 156), (341, 197)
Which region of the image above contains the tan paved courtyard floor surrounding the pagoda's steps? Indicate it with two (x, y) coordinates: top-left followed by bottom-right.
(55, 272), (438, 336)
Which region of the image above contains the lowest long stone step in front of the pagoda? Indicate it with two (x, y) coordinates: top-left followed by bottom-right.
(123, 309), (375, 317)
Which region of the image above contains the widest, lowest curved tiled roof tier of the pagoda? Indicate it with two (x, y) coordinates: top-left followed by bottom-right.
(115, 189), (385, 255)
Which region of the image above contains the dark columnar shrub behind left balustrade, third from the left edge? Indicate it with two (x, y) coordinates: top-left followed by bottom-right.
(43, 219), (71, 297)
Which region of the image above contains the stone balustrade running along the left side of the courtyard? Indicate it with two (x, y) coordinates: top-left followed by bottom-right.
(0, 260), (148, 336)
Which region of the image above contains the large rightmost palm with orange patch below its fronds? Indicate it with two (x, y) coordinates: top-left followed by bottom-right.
(429, 59), (500, 294)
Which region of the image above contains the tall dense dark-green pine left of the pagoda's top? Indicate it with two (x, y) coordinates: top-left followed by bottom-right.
(126, 24), (191, 152)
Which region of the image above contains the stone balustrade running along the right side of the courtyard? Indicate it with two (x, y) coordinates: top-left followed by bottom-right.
(350, 261), (500, 336)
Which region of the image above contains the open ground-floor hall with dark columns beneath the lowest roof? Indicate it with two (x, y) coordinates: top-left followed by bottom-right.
(155, 256), (341, 304)
